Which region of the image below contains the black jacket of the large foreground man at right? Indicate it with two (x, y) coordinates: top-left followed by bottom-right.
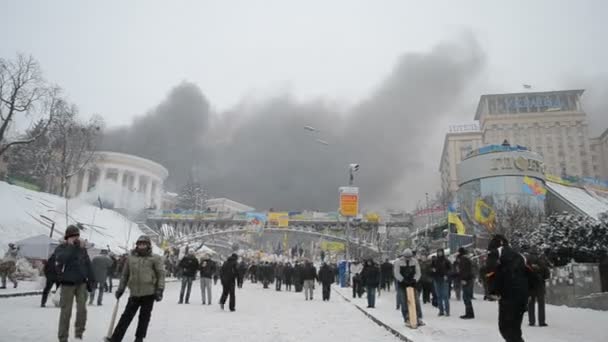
(486, 246), (528, 304)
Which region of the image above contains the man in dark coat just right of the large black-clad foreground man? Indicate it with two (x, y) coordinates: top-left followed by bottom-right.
(527, 252), (551, 327)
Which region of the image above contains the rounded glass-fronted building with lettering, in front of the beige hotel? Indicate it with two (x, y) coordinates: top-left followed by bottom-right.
(457, 145), (547, 235)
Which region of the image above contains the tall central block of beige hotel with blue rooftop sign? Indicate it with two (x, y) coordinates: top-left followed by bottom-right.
(475, 89), (599, 177)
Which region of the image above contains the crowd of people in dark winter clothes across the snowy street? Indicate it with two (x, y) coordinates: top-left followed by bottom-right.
(0, 226), (588, 342)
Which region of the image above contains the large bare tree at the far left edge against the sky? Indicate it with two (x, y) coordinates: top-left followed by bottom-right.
(0, 54), (59, 156)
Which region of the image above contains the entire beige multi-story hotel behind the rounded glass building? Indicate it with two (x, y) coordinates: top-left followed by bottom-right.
(439, 89), (608, 198)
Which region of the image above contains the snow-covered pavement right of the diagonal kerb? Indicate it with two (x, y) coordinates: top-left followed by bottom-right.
(334, 287), (608, 342)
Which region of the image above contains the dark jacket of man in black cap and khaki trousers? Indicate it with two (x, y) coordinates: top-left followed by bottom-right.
(54, 243), (95, 285)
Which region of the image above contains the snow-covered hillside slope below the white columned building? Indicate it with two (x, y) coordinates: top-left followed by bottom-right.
(0, 182), (157, 254)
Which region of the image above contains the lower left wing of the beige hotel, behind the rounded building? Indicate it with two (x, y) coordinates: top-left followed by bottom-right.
(439, 125), (482, 193)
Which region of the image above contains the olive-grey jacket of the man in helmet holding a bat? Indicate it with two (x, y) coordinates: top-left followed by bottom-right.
(118, 249), (165, 297)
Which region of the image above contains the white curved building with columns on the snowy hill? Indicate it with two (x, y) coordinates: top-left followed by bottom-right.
(68, 152), (169, 209)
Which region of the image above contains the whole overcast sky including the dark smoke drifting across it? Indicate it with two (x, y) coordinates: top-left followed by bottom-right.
(0, 0), (608, 209)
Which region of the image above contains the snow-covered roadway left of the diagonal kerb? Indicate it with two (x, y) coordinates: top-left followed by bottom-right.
(0, 282), (406, 342)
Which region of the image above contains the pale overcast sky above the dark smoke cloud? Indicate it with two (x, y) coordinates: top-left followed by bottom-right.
(0, 0), (608, 125)
